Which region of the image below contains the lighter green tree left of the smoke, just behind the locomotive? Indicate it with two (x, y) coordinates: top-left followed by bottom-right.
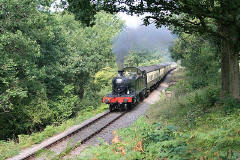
(75, 12), (123, 102)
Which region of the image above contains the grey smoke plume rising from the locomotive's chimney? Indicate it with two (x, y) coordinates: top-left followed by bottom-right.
(113, 25), (173, 70)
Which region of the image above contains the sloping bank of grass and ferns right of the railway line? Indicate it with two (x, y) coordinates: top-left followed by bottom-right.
(76, 70), (240, 160)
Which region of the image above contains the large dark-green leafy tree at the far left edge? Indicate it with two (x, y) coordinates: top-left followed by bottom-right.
(0, 0), (76, 139)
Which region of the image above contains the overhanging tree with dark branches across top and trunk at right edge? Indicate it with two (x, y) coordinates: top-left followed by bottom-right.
(66, 0), (240, 98)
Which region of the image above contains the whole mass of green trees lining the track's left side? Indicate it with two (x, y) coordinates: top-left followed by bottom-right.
(0, 0), (123, 139)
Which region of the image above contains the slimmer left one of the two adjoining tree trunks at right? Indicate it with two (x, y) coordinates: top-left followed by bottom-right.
(221, 40), (230, 98)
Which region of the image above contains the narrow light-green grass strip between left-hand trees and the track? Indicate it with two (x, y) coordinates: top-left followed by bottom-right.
(0, 104), (108, 159)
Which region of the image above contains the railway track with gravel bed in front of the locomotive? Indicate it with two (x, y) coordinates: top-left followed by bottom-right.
(9, 111), (125, 160)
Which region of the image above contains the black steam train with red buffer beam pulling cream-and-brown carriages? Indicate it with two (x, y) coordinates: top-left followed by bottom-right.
(103, 62), (176, 111)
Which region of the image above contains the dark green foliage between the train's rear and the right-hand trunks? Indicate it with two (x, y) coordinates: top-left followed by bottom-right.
(170, 34), (220, 89)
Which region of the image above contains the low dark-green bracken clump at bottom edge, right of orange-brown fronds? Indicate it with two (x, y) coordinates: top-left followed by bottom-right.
(143, 123), (191, 160)
